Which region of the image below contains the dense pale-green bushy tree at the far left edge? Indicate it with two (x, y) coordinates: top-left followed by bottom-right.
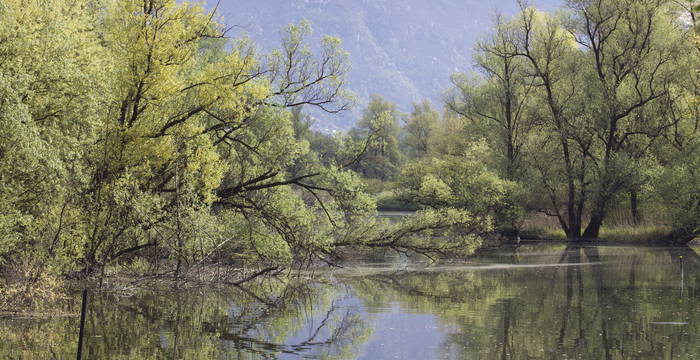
(0, 1), (111, 276)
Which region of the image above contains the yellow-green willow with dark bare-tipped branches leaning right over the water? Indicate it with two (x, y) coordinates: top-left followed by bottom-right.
(74, 0), (369, 277)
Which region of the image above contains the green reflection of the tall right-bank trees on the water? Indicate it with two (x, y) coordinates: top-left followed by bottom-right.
(348, 245), (700, 359)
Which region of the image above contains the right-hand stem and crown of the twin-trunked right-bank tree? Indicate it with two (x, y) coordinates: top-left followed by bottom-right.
(570, 0), (687, 238)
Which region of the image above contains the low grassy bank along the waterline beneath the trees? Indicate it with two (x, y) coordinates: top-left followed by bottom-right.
(0, 212), (700, 316)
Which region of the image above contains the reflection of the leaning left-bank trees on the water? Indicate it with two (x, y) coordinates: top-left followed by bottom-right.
(0, 282), (371, 359)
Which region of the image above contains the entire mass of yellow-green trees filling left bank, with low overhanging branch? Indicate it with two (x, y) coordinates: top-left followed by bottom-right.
(0, 0), (488, 302)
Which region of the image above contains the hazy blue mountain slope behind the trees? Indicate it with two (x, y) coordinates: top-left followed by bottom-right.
(207, 0), (564, 131)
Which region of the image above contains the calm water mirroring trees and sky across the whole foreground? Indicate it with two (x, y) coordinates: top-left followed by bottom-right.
(0, 245), (700, 360)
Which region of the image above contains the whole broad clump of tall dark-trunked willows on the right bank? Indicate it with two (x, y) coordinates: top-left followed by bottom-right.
(448, 0), (695, 239)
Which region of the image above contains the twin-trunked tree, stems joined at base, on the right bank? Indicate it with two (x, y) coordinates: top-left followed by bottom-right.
(492, 0), (683, 239)
